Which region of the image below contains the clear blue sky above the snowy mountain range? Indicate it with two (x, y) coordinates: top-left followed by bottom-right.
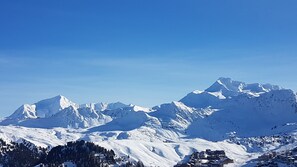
(0, 0), (297, 117)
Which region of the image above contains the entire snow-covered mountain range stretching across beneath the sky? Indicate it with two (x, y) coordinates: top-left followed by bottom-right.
(0, 78), (297, 140)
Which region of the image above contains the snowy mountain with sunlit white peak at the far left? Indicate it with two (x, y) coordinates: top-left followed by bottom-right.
(0, 95), (129, 128)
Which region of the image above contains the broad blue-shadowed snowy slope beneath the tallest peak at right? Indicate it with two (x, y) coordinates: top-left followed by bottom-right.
(182, 82), (297, 140)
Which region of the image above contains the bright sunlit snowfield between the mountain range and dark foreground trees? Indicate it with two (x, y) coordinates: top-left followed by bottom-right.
(0, 126), (255, 167)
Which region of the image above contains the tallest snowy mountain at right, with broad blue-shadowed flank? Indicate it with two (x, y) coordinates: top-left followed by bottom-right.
(180, 78), (297, 140)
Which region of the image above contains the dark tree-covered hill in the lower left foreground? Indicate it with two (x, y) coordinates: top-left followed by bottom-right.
(0, 139), (118, 167)
